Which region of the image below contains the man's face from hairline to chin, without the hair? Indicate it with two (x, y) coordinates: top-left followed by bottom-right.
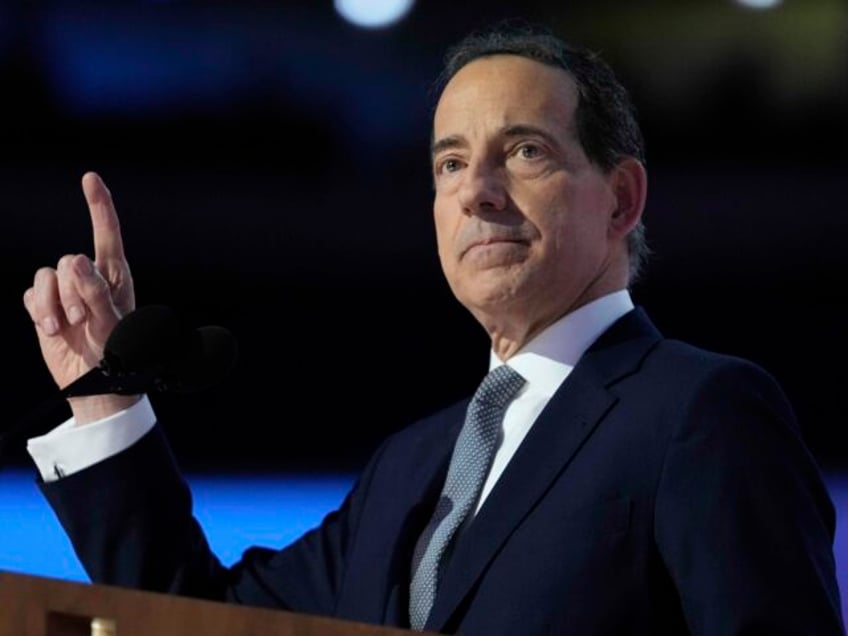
(432, 55), (626, 337)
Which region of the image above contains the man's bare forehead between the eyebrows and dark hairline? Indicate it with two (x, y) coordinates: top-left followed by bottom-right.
(433, 54), (578, 139)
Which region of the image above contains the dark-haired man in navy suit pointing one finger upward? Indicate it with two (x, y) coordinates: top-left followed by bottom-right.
(18, 22), (844, 636)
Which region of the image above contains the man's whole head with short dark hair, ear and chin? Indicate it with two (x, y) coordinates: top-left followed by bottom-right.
(432, 22), (647, 353)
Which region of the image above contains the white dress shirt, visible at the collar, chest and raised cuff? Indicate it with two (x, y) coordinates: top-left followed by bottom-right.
(27, 290), (633, 490)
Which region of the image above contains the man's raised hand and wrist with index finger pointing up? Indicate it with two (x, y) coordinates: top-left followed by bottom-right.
(23, 172), (135, 419)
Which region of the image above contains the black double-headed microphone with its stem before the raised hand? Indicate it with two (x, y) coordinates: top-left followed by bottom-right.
(0, 305), (238, 458)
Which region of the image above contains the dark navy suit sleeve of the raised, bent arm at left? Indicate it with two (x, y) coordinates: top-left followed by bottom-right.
(39, 425), (388, 614)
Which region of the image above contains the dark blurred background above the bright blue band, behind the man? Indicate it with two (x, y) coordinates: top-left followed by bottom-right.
(0, 0), (848, 470)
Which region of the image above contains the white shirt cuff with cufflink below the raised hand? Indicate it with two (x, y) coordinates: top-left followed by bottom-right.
(27, 395), (156, 481)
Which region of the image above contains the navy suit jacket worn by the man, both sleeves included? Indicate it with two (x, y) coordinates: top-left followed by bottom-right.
(41, 308), (844, 636)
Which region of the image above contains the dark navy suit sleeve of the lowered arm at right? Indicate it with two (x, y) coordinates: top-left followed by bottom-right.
(656, 361), (845, 636)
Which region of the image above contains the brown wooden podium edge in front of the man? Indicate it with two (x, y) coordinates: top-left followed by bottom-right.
(0, 571), (421, 636)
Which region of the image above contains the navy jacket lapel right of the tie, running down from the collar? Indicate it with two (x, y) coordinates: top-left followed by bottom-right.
(426, 309), (660, 631)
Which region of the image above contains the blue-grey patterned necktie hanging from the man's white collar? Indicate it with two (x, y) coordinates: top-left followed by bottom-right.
(409, 365), (525, 630)
